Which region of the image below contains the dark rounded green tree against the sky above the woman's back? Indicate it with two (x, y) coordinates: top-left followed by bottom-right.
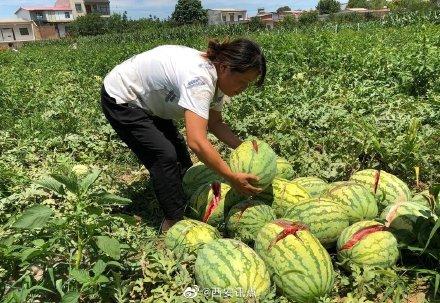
(171, 0), (208, 25)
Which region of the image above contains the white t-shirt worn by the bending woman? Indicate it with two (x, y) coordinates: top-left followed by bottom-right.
(104, 45), (228, 120)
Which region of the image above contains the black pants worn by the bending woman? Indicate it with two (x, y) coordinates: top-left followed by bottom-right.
(101, 86), (192, 220)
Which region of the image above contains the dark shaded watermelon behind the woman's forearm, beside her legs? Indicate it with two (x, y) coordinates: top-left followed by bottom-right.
(182, 162), (222, 197)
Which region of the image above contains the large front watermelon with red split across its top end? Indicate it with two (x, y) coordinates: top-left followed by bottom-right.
(255, 219), (334, 302)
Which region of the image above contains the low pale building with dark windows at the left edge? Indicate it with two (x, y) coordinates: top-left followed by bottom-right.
(0, 18), (36, 45)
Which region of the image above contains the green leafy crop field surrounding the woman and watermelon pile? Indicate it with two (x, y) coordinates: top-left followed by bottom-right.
(0, 17), (440, 302)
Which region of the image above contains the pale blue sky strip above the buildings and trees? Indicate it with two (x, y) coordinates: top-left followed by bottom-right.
(0, 0), (318, 19)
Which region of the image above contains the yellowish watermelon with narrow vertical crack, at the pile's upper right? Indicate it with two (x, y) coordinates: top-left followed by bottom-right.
(350, 169), (411, 208)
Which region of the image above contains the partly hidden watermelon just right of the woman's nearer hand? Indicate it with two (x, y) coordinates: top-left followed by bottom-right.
(256, 178), (310, 217)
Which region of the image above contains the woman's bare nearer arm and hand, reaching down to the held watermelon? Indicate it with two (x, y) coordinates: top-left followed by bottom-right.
(185, 110), (261, 196)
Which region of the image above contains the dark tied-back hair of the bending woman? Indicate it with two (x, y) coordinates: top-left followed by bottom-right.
(205, 39), (266, 86)
